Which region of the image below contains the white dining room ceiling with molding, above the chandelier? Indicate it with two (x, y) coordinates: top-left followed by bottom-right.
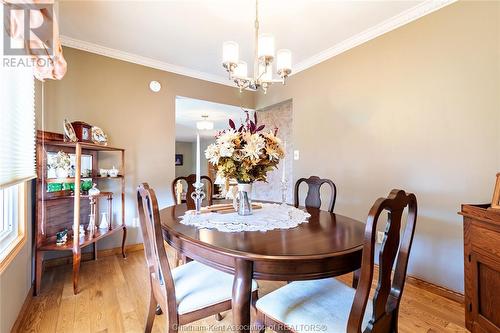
(59, 0), (454, 83)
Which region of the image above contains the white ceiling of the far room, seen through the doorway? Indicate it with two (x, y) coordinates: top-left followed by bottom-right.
(175, 96), (254, 142)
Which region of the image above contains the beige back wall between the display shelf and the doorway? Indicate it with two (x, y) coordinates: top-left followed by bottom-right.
(37, 48), (254, 247)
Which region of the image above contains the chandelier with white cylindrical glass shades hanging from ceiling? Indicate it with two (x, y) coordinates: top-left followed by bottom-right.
(222, 0), (292, 93)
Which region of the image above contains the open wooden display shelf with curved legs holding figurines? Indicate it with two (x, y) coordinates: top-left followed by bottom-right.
(35, 131), (127, 295)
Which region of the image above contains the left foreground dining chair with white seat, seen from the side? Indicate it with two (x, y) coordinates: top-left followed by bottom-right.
(137, 183), (258, 333)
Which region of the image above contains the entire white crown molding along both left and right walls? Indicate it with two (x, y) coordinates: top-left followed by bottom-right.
(60, 0), (457, 84)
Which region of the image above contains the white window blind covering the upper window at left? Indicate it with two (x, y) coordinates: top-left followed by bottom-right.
(0, 66), (36, 189)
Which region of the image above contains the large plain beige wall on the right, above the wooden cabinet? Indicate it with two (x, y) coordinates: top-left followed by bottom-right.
(256, 2), (500, 291)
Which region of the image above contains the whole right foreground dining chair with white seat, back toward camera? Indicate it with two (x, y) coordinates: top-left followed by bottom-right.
(256, 190), (417, 333)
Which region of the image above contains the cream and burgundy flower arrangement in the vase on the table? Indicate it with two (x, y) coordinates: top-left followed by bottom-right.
(205, 111), (285, 183)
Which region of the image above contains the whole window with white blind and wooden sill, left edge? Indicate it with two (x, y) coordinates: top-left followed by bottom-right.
(0, 54), (35, 273)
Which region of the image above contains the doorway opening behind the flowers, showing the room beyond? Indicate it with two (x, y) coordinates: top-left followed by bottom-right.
(175, 96), (293, 204)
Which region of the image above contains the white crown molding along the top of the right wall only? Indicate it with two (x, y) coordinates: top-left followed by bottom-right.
(292, 0), (457, 75)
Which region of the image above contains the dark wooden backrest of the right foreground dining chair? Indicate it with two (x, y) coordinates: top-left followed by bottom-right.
(347, 190), (417, 333)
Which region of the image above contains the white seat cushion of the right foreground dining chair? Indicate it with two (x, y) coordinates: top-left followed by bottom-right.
(257, 278), (372, 333)
